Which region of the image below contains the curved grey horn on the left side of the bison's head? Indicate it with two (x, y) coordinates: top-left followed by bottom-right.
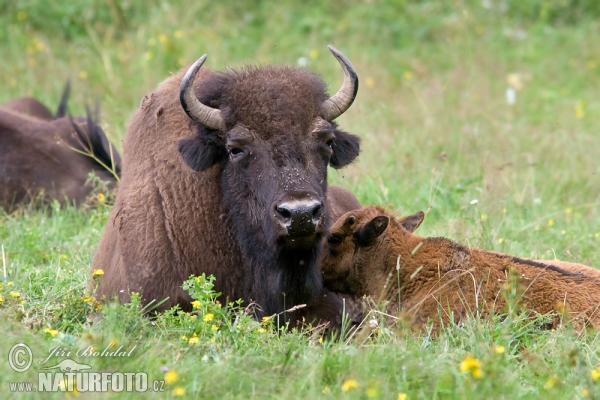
(179, 54), (224, 130)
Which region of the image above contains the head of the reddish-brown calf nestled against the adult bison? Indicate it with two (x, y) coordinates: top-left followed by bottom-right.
(322, 206), (425, 296)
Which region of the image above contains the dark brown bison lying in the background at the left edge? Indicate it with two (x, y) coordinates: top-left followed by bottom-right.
(0, 86), (120, 210)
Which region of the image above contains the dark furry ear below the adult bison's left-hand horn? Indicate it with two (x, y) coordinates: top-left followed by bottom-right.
(177, 135), (227, 171)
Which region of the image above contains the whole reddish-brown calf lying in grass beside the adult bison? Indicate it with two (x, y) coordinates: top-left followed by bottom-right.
(323, 206), (600, 330)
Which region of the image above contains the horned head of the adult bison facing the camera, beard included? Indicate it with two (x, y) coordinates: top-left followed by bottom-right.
(179, 46), (359, 313)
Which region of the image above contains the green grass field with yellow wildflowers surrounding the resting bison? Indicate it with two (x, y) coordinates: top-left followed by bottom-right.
(0, 0), (600, 399)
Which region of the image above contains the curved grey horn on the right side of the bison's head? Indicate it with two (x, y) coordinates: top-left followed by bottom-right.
(321, 46), (358, 121)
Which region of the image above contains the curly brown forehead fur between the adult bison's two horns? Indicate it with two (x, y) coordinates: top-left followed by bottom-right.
(195, 66), (329, 135)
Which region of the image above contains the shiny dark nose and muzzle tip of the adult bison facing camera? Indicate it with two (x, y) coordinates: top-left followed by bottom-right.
(275, 199), (323, 235)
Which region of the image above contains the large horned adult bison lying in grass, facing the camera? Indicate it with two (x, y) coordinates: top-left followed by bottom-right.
(92, 46), (359, 324)
